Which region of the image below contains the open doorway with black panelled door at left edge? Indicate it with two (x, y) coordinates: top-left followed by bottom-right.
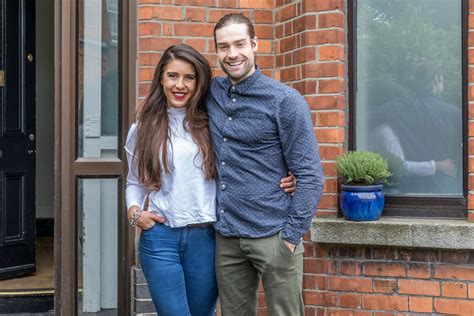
(0, 0), (54, 313)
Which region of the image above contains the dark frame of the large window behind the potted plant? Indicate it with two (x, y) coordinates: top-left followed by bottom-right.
(347, 0), (469, 218)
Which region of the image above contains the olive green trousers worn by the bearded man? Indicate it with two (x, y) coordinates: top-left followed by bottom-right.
(216, 233), (304, 316)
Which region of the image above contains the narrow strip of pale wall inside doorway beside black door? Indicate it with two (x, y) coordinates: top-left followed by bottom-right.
(36, 0), (54, 218)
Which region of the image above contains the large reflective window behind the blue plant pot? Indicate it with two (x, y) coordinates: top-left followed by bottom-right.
(348, 0), (467, 216)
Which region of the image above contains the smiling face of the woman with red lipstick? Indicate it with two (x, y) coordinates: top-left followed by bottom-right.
(161, 59), (197, 108)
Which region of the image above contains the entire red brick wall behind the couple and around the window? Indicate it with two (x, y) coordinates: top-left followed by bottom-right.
(132, 0), (474, 316)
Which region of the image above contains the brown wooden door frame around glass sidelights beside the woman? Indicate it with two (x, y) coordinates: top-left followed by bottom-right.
(54, 0), (137, 315)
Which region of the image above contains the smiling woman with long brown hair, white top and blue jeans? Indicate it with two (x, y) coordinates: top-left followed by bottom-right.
(125, 45), (294, 316)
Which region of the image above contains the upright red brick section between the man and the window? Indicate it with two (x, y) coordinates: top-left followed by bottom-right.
(275, 0), (346, 217)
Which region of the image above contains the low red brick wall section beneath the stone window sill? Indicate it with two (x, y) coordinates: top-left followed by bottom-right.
(304, 243), (474, 316)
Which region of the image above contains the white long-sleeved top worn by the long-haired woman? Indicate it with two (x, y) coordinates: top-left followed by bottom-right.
(125, 108), (216, 227)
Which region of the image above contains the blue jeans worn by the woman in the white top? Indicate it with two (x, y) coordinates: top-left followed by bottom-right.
(139, 223), (217, 316)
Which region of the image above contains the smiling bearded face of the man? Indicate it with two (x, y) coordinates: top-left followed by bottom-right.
(216, 23), (258, 84)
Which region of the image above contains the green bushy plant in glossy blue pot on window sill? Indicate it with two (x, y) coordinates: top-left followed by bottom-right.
(336, 151), (392, 221)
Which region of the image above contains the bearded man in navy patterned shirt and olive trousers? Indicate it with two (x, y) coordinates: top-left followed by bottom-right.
(208, 14), (324, 316)
